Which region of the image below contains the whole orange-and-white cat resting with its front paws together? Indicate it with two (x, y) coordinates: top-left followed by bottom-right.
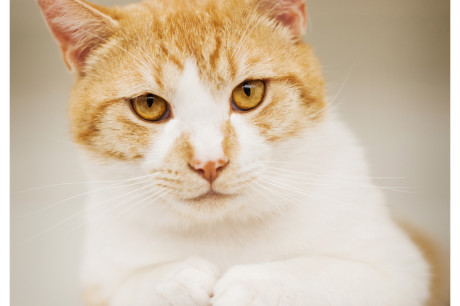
(38, 0), (430, 306)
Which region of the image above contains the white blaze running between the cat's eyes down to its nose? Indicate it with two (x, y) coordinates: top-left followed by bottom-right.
(173, 60), (230, 161)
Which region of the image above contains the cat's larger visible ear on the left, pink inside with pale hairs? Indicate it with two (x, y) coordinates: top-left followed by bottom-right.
(38, 0), (118, 72)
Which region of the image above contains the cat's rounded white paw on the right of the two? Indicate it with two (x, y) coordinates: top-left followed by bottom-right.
(212, 265), (289, 306)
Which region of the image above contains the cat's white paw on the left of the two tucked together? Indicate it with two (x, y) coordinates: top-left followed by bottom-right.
(152, 258), (219, 306)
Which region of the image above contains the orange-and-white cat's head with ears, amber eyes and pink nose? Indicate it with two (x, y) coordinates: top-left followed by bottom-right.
(38, 0), (325, 221)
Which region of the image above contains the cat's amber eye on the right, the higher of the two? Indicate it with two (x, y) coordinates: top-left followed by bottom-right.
(232, 80), (265, 111)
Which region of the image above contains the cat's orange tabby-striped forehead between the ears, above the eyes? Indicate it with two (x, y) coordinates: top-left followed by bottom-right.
(110, 1), (288, 91)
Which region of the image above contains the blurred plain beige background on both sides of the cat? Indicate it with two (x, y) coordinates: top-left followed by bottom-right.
(11, 0), (449, 306)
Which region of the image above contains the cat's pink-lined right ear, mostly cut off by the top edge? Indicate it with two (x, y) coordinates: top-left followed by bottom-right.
(258, 0), (307, 38)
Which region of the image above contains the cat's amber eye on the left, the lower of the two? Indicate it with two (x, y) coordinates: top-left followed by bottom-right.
(131, 94), (170, 121)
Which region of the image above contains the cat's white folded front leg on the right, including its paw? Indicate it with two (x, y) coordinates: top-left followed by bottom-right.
(212, 257), (428, 306)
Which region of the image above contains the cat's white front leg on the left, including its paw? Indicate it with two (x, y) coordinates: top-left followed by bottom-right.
(110, 258), (219, 306)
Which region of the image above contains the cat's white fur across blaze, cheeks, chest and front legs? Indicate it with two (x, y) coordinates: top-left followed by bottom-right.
(79, 62), (429, 306)
